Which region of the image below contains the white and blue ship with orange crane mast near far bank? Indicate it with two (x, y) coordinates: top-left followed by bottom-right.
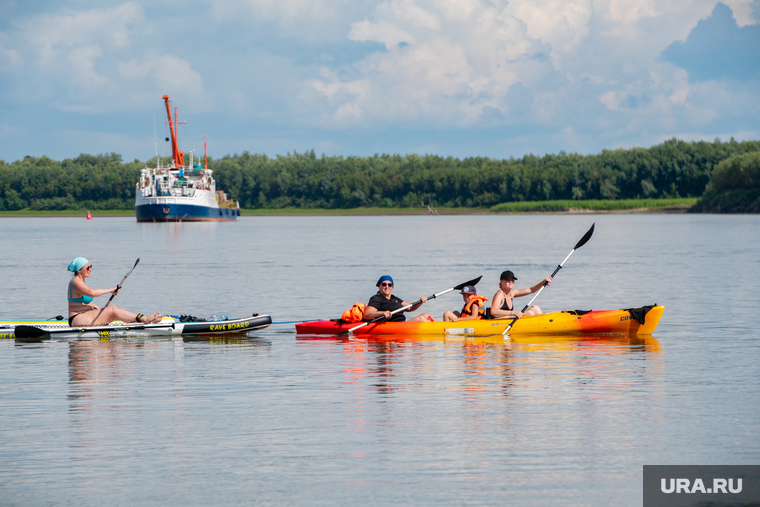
(135, 95), (240, 222)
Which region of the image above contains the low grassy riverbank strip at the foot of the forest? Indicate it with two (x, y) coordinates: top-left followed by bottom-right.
(0, 198), (697, 218)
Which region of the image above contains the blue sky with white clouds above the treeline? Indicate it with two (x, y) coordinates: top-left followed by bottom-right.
(0, 0), (760, 162)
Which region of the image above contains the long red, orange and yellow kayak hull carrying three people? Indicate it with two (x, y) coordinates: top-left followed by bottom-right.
(296, 305), (665, 336)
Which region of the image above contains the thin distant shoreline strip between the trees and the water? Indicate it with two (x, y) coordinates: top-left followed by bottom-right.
(0, 204), (694, 218)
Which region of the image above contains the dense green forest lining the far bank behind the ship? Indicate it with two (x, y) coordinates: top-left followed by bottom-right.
(0, 139), (760, 212)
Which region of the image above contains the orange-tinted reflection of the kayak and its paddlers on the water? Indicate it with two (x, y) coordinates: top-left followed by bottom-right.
(296, 335), (663, 401)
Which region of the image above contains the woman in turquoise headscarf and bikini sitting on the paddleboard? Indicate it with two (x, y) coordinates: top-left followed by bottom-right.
(67, 257), (161, 327)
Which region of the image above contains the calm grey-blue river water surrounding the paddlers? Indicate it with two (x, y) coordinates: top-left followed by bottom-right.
(0, 214), (760, 507)
